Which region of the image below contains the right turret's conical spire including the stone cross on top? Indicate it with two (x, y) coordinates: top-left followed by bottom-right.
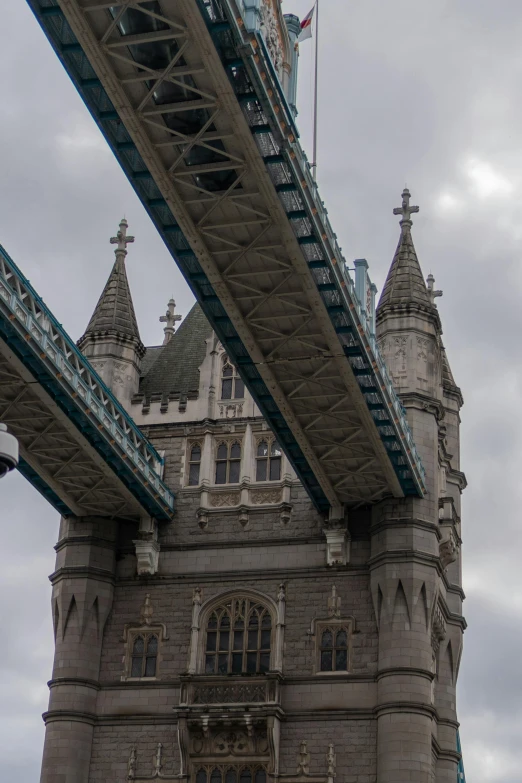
(377, 188), (436, 321)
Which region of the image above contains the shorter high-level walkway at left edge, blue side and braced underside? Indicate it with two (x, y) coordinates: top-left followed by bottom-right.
(0, 246), (174, 519)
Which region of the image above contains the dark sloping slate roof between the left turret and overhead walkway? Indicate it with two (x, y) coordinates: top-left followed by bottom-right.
(140, 304), (212, 396)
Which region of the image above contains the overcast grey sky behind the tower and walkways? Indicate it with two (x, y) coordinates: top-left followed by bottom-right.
(0, 0), (522, 783)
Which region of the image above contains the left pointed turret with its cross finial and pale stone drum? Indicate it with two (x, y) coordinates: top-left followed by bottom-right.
(78, 218), (145, 404)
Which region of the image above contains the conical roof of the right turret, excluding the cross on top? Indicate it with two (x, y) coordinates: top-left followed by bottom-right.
(377, 226), (436, 315)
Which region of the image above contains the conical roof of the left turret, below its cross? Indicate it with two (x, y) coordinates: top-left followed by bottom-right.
(78, 256), (141, 344)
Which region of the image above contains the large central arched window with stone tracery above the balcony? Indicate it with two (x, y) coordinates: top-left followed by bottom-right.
(205, 598), (272, 674)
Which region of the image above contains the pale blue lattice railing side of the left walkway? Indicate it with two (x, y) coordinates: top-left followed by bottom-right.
(0, 246), (174, 511)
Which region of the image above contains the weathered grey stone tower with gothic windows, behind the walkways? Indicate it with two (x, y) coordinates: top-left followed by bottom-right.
(41, 204), (465, 783)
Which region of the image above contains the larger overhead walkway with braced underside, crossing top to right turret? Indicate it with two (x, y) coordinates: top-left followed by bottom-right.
(28, 0), (425, 510)
